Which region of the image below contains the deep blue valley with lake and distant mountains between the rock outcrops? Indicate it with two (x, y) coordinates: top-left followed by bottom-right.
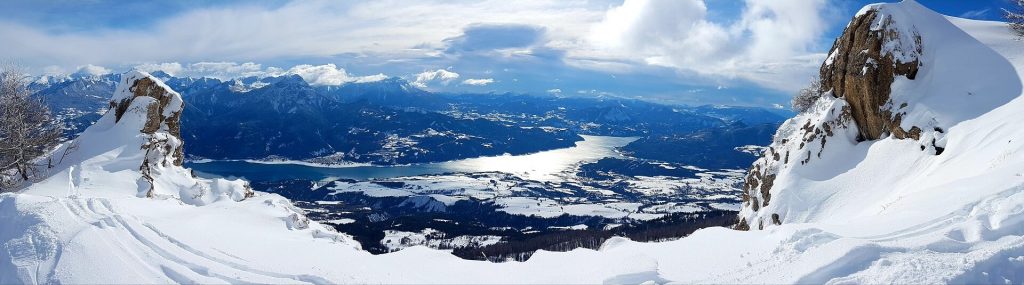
(33, 72), (782, 261)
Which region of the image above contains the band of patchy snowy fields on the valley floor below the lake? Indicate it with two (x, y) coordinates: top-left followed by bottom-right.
(326, 170), (743, 220)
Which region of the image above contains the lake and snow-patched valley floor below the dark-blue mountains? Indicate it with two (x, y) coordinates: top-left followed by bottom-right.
(186, 135), (754, 258)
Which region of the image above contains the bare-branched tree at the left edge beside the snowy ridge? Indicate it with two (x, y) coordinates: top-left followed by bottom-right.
(0, 68), (61, 190)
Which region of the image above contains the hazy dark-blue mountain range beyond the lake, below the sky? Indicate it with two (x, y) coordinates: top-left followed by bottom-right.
(33, 72), (781, 164)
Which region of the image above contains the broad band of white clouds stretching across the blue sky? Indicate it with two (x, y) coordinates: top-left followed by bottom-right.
(0, 0), (839, 95)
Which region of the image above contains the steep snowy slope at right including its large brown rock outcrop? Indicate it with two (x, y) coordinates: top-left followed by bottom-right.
(741, 1), (1024, 229)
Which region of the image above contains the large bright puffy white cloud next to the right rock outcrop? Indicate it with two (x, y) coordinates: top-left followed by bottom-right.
(590, 0), (827, 90)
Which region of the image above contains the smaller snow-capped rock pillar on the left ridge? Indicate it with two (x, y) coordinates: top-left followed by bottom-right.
(103, 72), (255, 201)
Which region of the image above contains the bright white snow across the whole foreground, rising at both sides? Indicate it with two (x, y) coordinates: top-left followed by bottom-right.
(0, 3), (1024, 284)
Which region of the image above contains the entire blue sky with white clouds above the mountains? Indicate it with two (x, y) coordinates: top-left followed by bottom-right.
(0, 0), (1011, 107)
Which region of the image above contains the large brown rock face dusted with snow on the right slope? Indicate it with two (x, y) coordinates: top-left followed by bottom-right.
(734, 4), (929, 231)
